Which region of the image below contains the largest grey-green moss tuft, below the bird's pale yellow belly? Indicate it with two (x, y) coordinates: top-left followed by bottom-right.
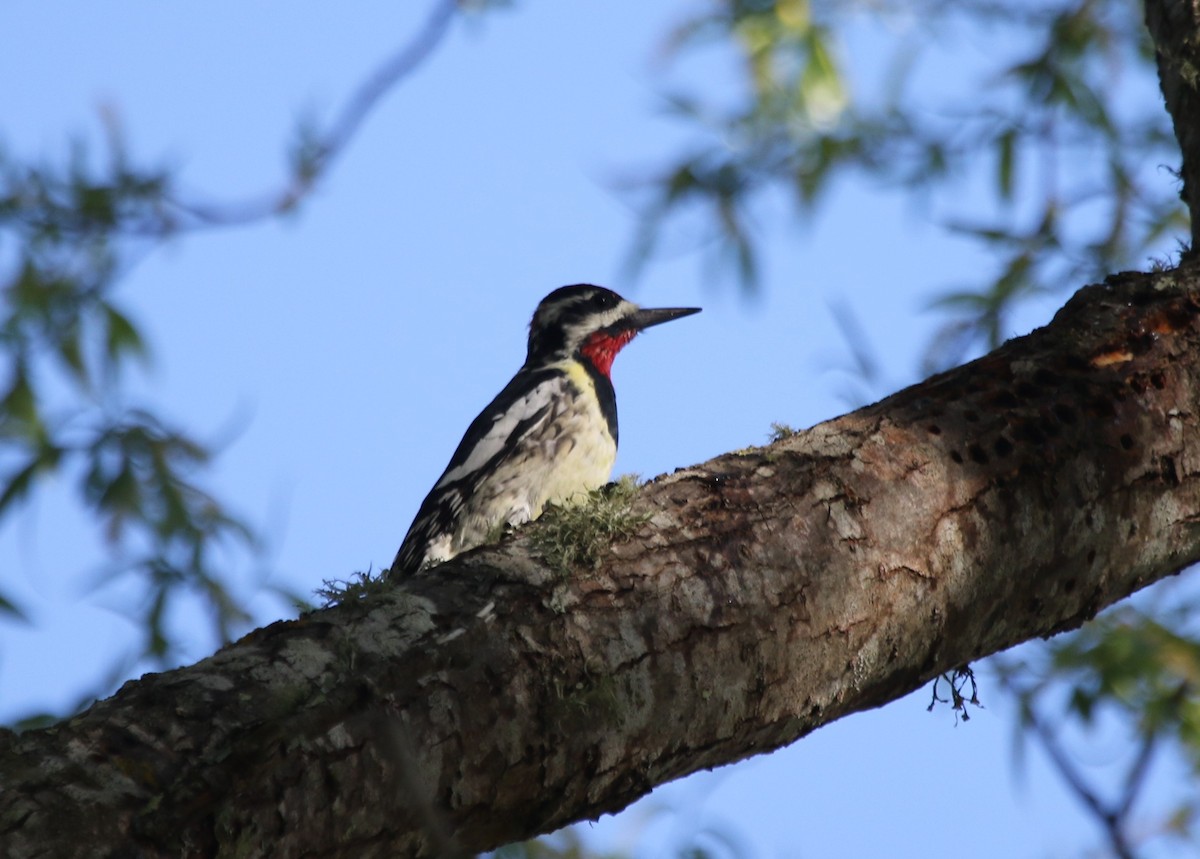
(530, 474), (650, 576)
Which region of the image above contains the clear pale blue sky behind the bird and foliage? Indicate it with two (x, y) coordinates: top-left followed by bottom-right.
(0, 0), (1172, 859)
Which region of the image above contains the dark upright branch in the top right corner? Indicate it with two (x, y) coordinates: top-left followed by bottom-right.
(1146, 0), (1200, 257)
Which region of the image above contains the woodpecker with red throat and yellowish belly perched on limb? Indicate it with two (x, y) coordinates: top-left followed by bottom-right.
(389, 283), (701, 577)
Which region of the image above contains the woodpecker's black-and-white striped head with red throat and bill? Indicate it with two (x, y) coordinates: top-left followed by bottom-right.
(526, 283), (700, 376)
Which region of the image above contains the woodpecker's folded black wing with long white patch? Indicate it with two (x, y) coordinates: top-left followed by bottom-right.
(391, 370), (564, 576)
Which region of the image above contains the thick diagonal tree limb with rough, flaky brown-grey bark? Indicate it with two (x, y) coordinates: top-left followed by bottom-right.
(7, 268), (1200, 858)
